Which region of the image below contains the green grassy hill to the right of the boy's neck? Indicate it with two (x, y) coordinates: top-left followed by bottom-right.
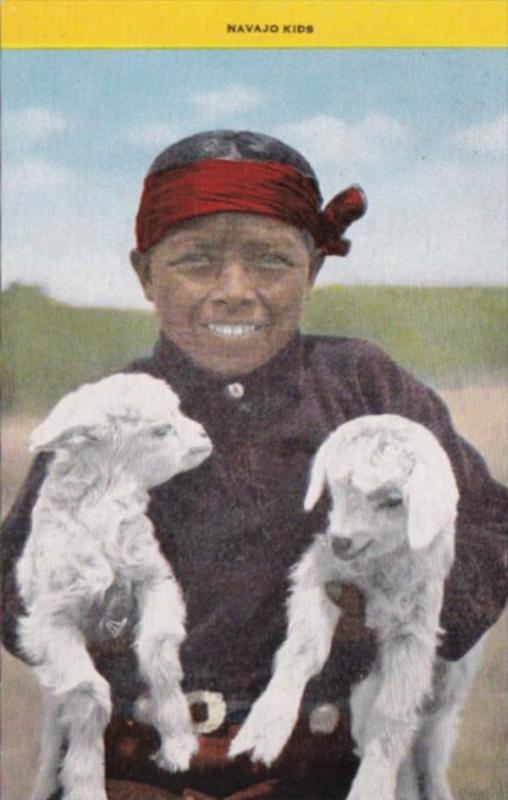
(303, 286), (508, 388)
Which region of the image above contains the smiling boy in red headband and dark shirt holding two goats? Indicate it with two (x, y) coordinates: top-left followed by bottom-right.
(3, 131), (507, 800)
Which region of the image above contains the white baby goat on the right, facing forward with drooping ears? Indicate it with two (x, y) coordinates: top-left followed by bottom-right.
(230, 415), (484, 800)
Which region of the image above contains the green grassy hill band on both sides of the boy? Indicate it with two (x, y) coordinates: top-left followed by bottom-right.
(2, 284), (508, 415)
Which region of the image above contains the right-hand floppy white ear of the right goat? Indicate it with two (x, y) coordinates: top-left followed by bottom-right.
(404, 464), (458, 550)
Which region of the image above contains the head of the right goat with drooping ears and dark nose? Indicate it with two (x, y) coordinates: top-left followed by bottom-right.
(305, 414), (458, 560)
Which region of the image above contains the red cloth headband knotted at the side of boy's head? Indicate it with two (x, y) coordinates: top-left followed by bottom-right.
(136, 159), (367, 256)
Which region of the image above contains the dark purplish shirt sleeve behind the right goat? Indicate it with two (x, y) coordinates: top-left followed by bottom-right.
(359, 348), (508, 661)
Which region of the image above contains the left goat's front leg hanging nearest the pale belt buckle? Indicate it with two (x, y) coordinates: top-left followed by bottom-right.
(136, 571), (197, 772)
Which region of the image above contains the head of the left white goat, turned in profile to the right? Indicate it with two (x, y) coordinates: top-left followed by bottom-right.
(30, 374), (212, 489)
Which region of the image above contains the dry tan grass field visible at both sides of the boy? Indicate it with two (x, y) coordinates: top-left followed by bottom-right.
(1, 385), (508, 800)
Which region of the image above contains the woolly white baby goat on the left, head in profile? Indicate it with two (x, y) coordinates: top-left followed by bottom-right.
(17, 374), (211, 800)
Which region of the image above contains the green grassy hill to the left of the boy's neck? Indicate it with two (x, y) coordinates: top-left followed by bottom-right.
(2, 284), (157, 415)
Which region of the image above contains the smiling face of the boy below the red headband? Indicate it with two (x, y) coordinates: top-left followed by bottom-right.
(132, 213), (314, 375)
